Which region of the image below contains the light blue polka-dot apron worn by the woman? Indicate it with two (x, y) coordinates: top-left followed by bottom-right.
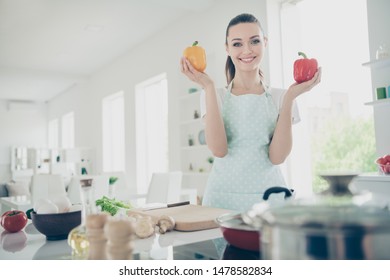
(202, 86), (286, 212)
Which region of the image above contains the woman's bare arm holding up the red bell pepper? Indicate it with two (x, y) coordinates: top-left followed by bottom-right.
(269, 68), (321, 164)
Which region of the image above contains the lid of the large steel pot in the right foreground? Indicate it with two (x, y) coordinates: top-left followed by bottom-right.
(259, 204), (390, 230)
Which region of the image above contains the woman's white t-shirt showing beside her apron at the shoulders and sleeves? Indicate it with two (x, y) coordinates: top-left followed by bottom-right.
(200, 88), (301, 124)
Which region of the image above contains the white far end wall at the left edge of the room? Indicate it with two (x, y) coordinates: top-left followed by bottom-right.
(0, 100), (47, 183)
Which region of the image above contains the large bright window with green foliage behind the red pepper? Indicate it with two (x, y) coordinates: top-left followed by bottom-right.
(280, 0), (375, 193)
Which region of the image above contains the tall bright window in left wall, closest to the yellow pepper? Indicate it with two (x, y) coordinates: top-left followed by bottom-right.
(135, 74), (168, 193)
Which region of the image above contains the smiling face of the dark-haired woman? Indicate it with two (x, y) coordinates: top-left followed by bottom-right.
(226, 23), (266, 71)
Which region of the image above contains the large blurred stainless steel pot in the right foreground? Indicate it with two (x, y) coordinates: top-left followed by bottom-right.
(254, 175), (390, 260)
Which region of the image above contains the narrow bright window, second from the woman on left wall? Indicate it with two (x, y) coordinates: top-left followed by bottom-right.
(102, 91), (125, 172)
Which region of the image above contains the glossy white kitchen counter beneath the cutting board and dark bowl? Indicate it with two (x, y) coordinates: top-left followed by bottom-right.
(0, 222), (259, 260)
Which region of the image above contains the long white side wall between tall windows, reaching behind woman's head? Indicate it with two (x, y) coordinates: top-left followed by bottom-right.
(48, 0), (268, 195)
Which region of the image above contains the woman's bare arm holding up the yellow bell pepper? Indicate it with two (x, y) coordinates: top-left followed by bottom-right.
(181, 57), (228, 157)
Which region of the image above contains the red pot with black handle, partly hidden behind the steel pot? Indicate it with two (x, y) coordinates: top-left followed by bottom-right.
(216, 186), (293, 252)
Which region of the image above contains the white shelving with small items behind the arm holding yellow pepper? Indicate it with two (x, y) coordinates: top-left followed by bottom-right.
(180, 91), (213, 196)
